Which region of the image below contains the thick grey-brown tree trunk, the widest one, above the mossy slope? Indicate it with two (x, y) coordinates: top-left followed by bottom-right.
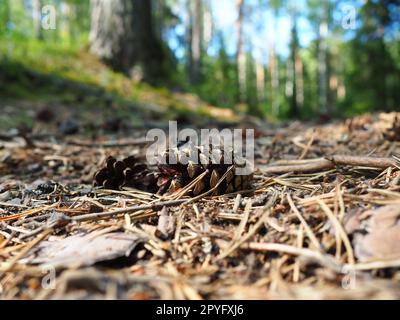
(90, 0), (164, 82)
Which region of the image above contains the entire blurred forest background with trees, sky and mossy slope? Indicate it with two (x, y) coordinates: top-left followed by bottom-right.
(0, 0), (400, 125)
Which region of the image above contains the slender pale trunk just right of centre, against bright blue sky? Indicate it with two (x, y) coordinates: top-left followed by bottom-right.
(236, 0), (246, 102)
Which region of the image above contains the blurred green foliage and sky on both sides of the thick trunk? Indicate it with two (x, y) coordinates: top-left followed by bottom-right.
(0, 0), (400, 119)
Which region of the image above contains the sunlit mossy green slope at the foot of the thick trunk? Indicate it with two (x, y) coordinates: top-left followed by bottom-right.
(0, 40), (236, 130)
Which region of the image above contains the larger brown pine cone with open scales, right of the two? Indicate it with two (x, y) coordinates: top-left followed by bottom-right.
(157, 146), (253, 196)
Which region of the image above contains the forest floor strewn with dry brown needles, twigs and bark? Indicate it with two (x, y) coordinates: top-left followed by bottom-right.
(0, 109), (400, 299)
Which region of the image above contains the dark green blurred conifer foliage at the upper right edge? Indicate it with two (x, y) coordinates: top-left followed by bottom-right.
(345, 0), (400, 115)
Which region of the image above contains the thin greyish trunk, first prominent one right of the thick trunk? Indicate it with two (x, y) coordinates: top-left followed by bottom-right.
(189, 0), (203, 84)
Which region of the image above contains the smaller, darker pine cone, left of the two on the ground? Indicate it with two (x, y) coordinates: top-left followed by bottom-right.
(93, 156), (156, 192)
